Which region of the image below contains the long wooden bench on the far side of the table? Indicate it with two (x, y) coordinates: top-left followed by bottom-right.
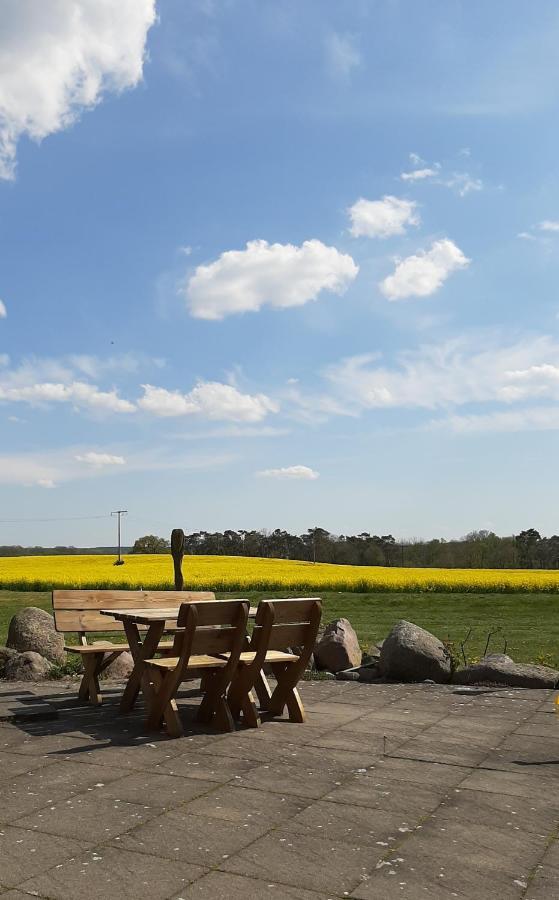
(52, 590), (215, 705)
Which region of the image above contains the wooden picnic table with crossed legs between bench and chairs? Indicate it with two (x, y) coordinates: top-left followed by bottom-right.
(99, 601), (257, 713)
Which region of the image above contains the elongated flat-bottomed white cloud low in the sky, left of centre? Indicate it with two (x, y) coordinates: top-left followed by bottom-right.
(138, 381), (278, 422)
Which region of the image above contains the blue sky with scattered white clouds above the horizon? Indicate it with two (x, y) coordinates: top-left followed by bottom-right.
(0, 0), (559, 545)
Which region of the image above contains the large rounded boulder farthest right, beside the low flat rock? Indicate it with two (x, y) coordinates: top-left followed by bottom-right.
(380, 620), (451, 683)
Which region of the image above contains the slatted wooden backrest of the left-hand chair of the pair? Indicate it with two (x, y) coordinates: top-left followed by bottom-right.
(175, 600), (249, 668)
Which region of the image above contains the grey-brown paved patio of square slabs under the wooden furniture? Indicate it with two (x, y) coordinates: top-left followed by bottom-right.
(0, 682), (559, 900)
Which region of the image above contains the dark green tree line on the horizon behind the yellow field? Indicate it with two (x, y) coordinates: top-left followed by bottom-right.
(132, 528), (559, 569)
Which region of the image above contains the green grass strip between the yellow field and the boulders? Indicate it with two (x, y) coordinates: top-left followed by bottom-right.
(0, 591), (559, 668)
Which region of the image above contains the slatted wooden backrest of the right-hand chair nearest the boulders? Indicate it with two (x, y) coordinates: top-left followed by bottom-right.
(251, 597), (322, 660)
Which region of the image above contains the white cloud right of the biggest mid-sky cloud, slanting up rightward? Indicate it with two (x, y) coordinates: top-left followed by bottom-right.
(379, 238), (470, 300)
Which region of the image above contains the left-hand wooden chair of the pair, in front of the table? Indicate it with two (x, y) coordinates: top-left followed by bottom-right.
(146, 600), (249, 737)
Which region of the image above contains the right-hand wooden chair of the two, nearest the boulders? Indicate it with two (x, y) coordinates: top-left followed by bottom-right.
(228, 597), (322, 728)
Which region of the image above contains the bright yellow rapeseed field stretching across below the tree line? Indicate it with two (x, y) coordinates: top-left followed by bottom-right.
(0, 554), (559, 593)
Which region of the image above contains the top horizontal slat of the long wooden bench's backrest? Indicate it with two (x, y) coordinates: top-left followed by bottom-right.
(52, 590), (215, 609)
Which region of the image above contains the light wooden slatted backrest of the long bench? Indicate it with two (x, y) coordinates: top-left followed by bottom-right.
(52, 590), (215, 640)
